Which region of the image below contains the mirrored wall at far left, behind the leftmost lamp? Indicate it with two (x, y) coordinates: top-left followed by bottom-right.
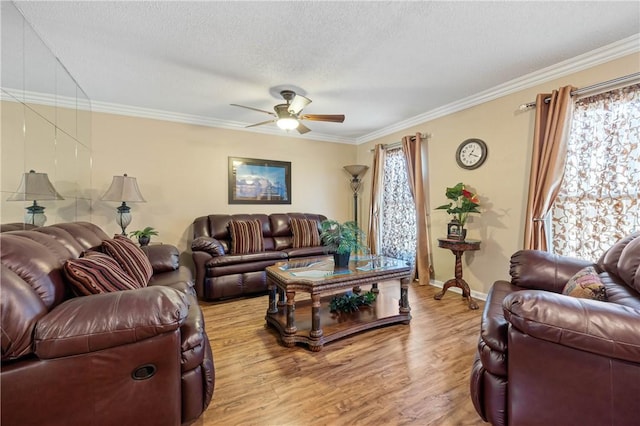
(0, 2), (92, 228)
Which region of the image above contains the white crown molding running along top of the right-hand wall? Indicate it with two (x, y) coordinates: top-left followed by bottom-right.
(356, 33), (640, 145)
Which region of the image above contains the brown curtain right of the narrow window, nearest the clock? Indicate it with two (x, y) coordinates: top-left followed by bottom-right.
(402, 133), (433, 285)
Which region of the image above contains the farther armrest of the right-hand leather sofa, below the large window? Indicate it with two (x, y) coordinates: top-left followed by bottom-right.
(509, 250), (597, 293)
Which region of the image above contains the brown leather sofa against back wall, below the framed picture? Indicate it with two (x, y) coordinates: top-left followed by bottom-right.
(191, 213), (328, 300)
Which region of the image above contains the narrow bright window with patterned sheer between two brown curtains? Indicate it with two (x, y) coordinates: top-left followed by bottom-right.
(380, 149), (417, 265)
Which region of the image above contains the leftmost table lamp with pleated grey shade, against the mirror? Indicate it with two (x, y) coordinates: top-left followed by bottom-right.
(7, 170), (64, 226)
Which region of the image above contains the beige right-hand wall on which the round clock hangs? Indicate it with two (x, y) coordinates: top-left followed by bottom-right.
(357, 54), (640, 294)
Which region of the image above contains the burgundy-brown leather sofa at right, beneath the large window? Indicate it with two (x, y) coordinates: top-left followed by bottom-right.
(471, 233), (640, 426)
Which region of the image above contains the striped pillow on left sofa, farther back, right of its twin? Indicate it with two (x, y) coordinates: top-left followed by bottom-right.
(102, 235), (153, 287)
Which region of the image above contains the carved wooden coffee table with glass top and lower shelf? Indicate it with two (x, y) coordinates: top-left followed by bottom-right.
(265, 256), (411, 352)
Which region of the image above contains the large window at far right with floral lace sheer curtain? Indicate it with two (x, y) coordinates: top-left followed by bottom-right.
(550, 84), (640, 260)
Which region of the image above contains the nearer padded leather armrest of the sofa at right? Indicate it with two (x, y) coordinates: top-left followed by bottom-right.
(502, 290), (640, 363)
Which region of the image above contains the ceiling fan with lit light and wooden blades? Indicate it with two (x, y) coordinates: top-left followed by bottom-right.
(231, 90), (344, 135)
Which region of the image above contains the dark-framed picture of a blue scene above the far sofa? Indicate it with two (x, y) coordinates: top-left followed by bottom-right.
(228, 157), (291, 204)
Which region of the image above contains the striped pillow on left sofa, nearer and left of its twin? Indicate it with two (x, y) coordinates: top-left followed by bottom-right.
(64, 252), (140, 296)
